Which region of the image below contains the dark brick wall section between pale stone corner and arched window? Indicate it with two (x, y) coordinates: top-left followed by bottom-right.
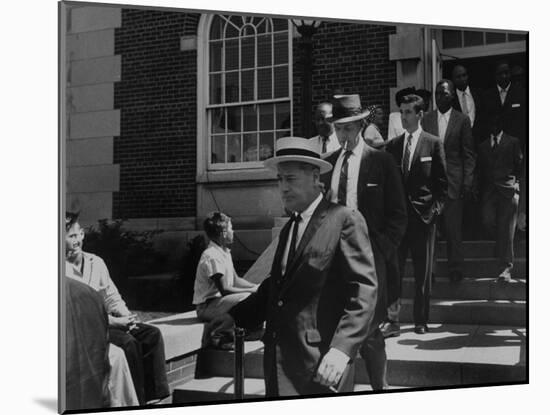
(113, 9), (197, 218)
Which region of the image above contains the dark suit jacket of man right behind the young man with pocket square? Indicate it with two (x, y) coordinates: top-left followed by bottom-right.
(422, 109), (476, 199)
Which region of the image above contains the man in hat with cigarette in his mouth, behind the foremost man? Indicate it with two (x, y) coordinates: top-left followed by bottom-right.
(323, 95), (407, 390)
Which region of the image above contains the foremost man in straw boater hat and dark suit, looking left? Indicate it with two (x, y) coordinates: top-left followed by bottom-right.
(208, 137), (378, 397)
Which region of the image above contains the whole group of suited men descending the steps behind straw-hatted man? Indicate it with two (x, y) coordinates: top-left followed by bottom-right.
(208, 57), (527, 396)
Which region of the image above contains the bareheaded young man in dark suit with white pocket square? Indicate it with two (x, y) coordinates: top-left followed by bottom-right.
(386, 95), (447, 334)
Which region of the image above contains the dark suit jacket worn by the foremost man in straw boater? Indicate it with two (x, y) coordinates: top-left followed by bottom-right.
(230, 199), (378, 396)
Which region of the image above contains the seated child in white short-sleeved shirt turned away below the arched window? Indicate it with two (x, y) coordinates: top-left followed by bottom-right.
(193, 212), (258, 321)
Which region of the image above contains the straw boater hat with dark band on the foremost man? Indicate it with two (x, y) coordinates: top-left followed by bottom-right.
(264, 137), (332, 174)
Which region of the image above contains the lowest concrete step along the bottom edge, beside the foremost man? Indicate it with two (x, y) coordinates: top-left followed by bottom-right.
(172, 376), (408, 404)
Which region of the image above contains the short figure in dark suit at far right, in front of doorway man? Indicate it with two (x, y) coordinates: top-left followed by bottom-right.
(479, 117), (523, 282)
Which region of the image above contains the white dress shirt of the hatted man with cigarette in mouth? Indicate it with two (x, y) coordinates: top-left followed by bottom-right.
(330, 133), (365, 210)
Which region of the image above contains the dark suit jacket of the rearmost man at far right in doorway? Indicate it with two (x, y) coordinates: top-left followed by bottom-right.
(483, 83), (527, 151)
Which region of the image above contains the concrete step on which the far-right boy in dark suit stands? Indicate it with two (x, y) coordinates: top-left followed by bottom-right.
(401, 278), (527, 300)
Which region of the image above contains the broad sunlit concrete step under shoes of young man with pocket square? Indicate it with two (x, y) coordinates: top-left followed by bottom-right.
(197, 324), (527, 391)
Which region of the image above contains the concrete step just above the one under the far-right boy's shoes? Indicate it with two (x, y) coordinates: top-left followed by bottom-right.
(405, 257), (527, 278)
